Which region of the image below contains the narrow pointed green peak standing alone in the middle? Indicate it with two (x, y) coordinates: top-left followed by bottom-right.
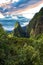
(14, 22), (26, 37)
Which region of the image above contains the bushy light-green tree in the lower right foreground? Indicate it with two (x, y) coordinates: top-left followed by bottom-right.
(17, 45), (40, 65)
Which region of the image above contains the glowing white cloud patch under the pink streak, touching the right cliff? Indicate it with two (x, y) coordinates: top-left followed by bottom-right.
(21, 4), (43, 19)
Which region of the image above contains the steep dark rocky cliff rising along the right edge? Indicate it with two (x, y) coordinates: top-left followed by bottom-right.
(27, 8), (43, 36)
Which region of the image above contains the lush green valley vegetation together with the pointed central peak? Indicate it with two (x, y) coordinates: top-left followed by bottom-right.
(0, 7), (43, 65)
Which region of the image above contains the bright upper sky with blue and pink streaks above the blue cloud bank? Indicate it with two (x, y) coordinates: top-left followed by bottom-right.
(0, 0), (43, 19)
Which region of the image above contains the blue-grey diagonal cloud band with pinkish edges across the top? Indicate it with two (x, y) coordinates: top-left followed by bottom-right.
(0, 0), (40, 13)
